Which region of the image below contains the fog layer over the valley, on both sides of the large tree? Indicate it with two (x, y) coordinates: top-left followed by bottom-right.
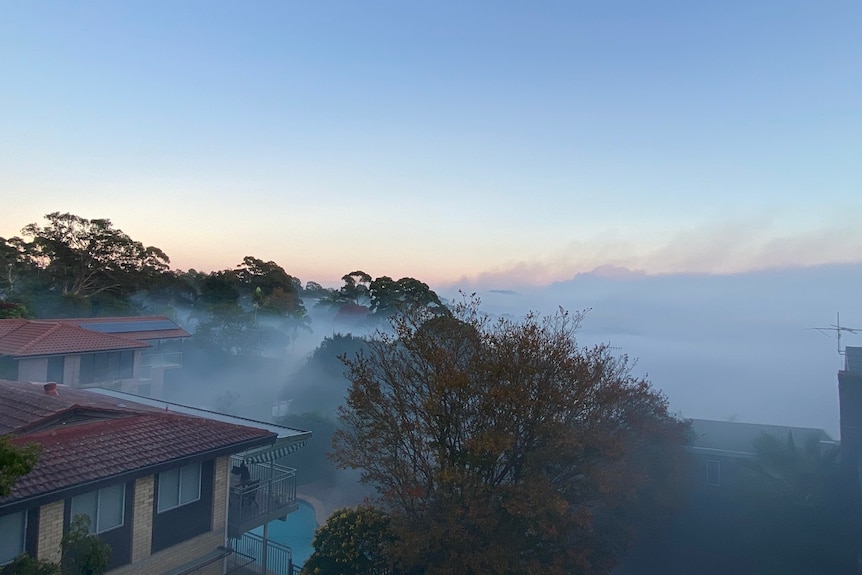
(176, 265), (862, 438)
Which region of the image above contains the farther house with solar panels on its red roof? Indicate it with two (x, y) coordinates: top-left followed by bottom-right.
(0, 316), (189, 397)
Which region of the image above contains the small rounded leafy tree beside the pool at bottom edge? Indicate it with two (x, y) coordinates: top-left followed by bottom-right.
(301, 505), (394, 575)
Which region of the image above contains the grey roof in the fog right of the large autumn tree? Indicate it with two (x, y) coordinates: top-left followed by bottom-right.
(691, 419), (836, 455)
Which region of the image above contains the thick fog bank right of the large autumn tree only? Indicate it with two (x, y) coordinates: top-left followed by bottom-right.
(440, 265), (862, 438)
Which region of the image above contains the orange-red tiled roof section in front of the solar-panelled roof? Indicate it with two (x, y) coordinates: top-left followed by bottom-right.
(0, 319), (150, 357)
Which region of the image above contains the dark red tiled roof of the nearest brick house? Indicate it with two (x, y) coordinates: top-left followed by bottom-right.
(0, 380), (276, 508)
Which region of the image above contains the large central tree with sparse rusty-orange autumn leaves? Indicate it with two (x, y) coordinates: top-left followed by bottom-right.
(333, 301), (688, 574)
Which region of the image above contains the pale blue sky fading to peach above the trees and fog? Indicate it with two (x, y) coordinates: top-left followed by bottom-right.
(0, 0), (862, 287)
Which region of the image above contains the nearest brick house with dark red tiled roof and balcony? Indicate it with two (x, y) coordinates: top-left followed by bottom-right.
(0, 380), (310, 575)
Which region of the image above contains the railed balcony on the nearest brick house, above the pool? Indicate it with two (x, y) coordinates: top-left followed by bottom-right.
(227, 458), (298, 538)
